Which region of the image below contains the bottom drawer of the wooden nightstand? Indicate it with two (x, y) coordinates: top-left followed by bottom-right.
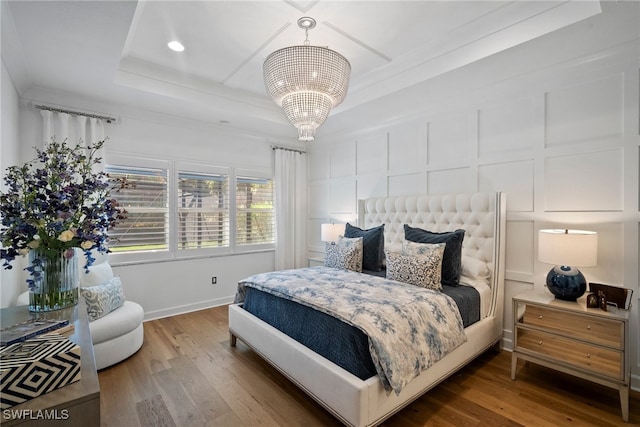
(516, 330), (623, 380)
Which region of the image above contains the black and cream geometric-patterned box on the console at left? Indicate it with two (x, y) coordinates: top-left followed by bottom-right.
(0, 333), (80, 409)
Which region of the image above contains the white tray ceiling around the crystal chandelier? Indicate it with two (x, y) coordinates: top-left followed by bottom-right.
(2, 0), (600, 137)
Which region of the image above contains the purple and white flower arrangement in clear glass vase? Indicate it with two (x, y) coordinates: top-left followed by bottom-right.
(0, 139), (126, 312)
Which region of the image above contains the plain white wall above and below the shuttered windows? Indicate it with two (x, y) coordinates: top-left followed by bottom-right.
(13, 89), (292, 319)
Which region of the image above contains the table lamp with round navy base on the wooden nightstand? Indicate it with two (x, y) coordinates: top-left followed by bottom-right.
(538, 230), (598, 301)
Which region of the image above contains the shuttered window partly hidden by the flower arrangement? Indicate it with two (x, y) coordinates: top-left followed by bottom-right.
(105, 166), (169, 252)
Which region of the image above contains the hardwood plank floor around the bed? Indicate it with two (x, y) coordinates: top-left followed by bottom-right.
(99, 306), (640, 427)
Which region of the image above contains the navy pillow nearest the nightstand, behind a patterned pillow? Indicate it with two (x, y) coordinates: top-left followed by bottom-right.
(404, 224), (464, 286)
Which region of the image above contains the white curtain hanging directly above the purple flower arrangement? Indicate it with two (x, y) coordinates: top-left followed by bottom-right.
(40, 110), (105, 171)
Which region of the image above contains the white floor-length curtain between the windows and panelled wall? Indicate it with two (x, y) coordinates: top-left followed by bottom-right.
(274, 148), (308, 270)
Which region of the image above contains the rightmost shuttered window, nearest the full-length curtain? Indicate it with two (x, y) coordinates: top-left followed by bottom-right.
(236, 177), (275, 245)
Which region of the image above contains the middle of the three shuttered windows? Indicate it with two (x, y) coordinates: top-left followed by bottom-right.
(177, 172), (229, 250)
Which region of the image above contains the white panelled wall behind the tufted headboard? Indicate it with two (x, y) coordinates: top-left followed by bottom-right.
(308, 2), (640, 388)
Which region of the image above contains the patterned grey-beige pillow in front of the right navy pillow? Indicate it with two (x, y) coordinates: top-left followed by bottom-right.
(385, 245), (444, 291)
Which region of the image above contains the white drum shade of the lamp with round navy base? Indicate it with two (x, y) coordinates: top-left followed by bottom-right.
(538, 229), (598, 267)
